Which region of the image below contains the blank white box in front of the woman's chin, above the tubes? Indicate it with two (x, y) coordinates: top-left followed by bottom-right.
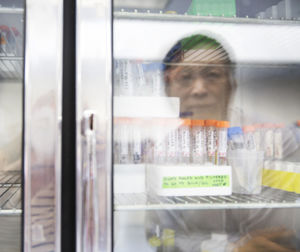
(114, 96), (180, 118)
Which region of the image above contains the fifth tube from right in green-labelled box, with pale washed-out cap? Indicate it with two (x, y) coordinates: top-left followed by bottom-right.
(165, 118), (179, 164)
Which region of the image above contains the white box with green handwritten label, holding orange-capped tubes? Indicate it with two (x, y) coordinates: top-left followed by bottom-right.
(146, 164), (232, 196)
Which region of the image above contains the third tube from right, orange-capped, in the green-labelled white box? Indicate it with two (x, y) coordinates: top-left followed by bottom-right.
(191, 120), (206, 164)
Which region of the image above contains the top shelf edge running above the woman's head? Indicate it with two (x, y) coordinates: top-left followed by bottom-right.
(114, 11), (300, 25)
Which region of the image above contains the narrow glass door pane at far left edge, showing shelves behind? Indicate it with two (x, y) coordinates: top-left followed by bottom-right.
(0, 1), (24, 251)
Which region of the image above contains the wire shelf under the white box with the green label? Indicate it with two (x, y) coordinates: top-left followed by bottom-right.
(114, 187), (300, 211)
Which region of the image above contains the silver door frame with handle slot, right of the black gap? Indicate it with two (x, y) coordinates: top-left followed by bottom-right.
(76, 0), (112, 252)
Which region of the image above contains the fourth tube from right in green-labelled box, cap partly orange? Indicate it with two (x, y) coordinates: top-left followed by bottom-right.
(179, 119), (191, 164)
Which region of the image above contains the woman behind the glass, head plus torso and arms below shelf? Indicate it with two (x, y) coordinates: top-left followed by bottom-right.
(146, 35), (297, 252)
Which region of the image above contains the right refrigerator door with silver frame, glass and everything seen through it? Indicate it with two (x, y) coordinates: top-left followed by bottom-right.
(76, 0), (300, 252)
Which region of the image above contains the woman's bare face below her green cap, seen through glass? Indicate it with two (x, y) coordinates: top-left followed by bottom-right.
(165, 62), (231, 120)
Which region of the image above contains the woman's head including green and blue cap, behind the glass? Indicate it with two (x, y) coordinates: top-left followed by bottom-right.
(164, 35), (235, 120)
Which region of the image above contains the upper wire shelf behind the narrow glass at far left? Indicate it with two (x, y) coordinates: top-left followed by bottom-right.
(0, 55), (23, 80)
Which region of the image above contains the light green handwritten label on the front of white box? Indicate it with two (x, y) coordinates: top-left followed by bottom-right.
(162, 175), (229, 189)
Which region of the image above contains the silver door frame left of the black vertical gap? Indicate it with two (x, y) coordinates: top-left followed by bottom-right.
(23, 0), (63, 252)
